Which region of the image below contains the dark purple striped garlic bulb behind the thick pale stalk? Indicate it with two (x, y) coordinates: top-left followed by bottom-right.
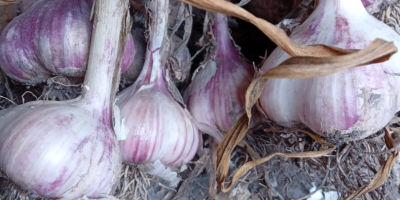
(0, 0), (134, 84)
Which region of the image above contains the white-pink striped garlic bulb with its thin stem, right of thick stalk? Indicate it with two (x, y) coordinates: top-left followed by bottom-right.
(117, 0), (199, 165)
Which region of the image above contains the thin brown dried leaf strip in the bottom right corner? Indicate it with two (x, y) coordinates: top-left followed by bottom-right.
(345, 127), (399, 200)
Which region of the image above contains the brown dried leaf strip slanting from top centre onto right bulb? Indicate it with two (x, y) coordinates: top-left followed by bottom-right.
(180, 0), (356, 57)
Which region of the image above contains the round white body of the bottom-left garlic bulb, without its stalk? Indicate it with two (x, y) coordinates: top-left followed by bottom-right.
(0, 100), (121, 199)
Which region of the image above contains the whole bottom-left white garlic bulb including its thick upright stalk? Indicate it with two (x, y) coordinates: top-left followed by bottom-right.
(0, 0), (129, 199)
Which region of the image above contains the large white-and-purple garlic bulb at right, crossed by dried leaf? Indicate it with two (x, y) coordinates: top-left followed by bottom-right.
(259, 0), (400, 140)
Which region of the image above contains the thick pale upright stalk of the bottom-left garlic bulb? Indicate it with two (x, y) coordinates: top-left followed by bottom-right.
(83, 0), (130, 113)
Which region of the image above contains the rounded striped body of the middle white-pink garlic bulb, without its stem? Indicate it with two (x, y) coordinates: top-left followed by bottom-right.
(117, 71), (199, 165)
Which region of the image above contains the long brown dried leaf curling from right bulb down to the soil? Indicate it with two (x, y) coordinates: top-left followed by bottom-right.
(217, 39), (397, 192)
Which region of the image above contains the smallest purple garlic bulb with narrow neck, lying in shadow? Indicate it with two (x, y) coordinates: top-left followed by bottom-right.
(184, 14), (254, 132)
